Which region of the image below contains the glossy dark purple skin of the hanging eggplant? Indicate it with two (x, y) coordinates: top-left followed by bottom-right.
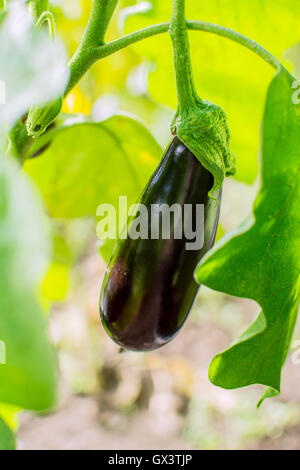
(100, 137), (221, 351)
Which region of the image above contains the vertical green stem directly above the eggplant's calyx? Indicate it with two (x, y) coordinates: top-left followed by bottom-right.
(169, 0), (199, 113)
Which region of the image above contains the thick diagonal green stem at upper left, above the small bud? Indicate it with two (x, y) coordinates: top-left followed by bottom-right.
(65, 0), (118, 95)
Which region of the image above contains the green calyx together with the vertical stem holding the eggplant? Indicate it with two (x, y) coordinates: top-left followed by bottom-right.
(170, 0), (235, 197)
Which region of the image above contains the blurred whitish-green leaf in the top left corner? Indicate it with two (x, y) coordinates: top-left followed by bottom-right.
(0, 2), (69, 129)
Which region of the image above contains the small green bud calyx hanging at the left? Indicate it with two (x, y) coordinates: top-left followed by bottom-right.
(26, 97), (62, 138)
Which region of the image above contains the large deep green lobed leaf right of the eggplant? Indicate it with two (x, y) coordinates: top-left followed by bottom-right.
(195, 70), (300, 395)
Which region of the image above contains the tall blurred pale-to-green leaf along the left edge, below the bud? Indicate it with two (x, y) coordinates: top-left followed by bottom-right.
(0, 158), (56, 411)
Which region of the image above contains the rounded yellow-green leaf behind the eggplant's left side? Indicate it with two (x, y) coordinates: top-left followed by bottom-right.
(24, 115), (162, 260)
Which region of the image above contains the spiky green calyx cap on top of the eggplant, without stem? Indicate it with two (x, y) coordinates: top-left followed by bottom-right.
(171, 101), (236, 193)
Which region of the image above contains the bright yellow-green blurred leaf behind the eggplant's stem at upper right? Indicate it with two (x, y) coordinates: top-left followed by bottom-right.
(123, 0), (300, 183)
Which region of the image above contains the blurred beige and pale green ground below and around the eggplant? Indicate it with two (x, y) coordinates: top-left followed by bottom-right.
(18, 182), (300, 450)
